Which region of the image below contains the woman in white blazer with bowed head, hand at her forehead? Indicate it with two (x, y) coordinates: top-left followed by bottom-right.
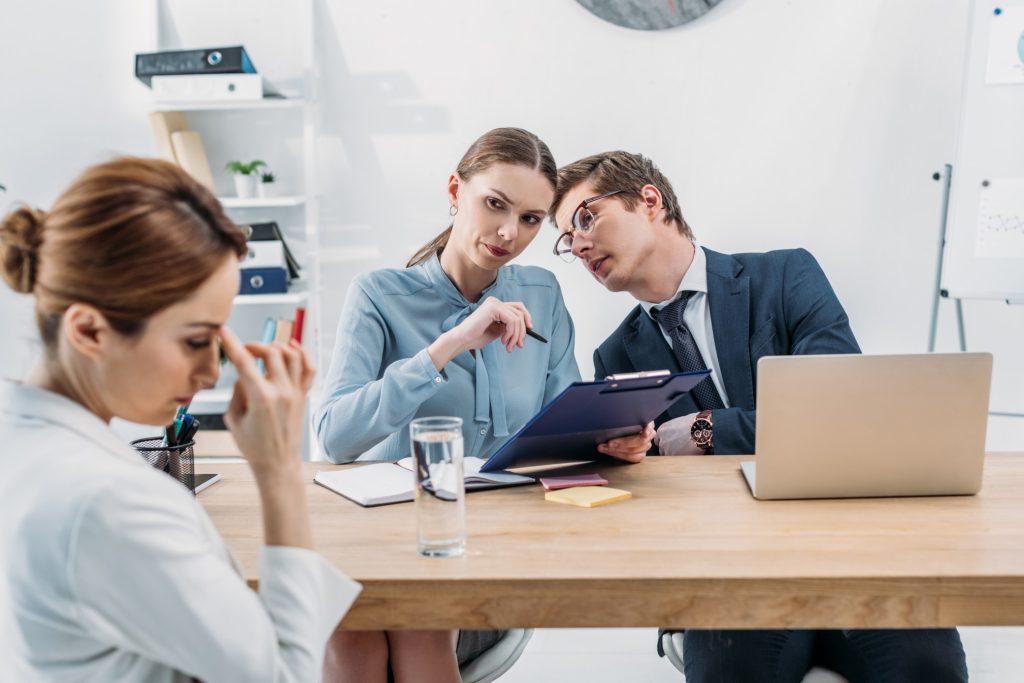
(0, 159), (359, 683)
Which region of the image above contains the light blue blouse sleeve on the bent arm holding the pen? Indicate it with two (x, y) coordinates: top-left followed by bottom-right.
(314, 276), (447, 463)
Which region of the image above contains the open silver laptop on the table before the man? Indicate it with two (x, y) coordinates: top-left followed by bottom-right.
(741, 353), (992, 500)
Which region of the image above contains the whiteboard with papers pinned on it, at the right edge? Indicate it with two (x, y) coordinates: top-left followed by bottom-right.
(942, 0), (1024, 302)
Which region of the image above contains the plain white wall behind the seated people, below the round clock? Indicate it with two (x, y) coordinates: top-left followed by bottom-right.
(0, 0), (1024, 450)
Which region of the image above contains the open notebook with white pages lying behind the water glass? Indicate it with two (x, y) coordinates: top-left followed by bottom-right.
(313, 458), (535, 508)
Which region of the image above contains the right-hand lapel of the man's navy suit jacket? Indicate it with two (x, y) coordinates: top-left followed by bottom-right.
(705, 249), (754, 409)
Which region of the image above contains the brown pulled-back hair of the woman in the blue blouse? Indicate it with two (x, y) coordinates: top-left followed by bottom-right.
(406, 128), (558, 268)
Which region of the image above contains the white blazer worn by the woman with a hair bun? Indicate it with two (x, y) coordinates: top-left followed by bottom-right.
(0, 382), (360, 683)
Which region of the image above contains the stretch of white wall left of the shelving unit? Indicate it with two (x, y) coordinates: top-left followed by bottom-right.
(0, 0), (154, 377)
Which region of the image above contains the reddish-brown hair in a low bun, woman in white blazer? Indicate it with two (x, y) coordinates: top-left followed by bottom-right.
(0, 157), (246, 351)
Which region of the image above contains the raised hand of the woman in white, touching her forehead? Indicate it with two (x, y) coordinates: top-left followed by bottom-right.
(220, 327), (313, 474)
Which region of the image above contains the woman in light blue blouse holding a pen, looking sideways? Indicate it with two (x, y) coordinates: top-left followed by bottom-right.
(315, 128), (653, 683)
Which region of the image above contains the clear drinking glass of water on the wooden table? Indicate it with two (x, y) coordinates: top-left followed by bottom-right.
(409, 418), (466, 557)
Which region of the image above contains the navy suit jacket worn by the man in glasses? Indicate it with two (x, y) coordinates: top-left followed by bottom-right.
(594, 249), (860, 455)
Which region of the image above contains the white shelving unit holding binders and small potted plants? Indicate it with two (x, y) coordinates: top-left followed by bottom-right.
(152, 0), (322, 460)
